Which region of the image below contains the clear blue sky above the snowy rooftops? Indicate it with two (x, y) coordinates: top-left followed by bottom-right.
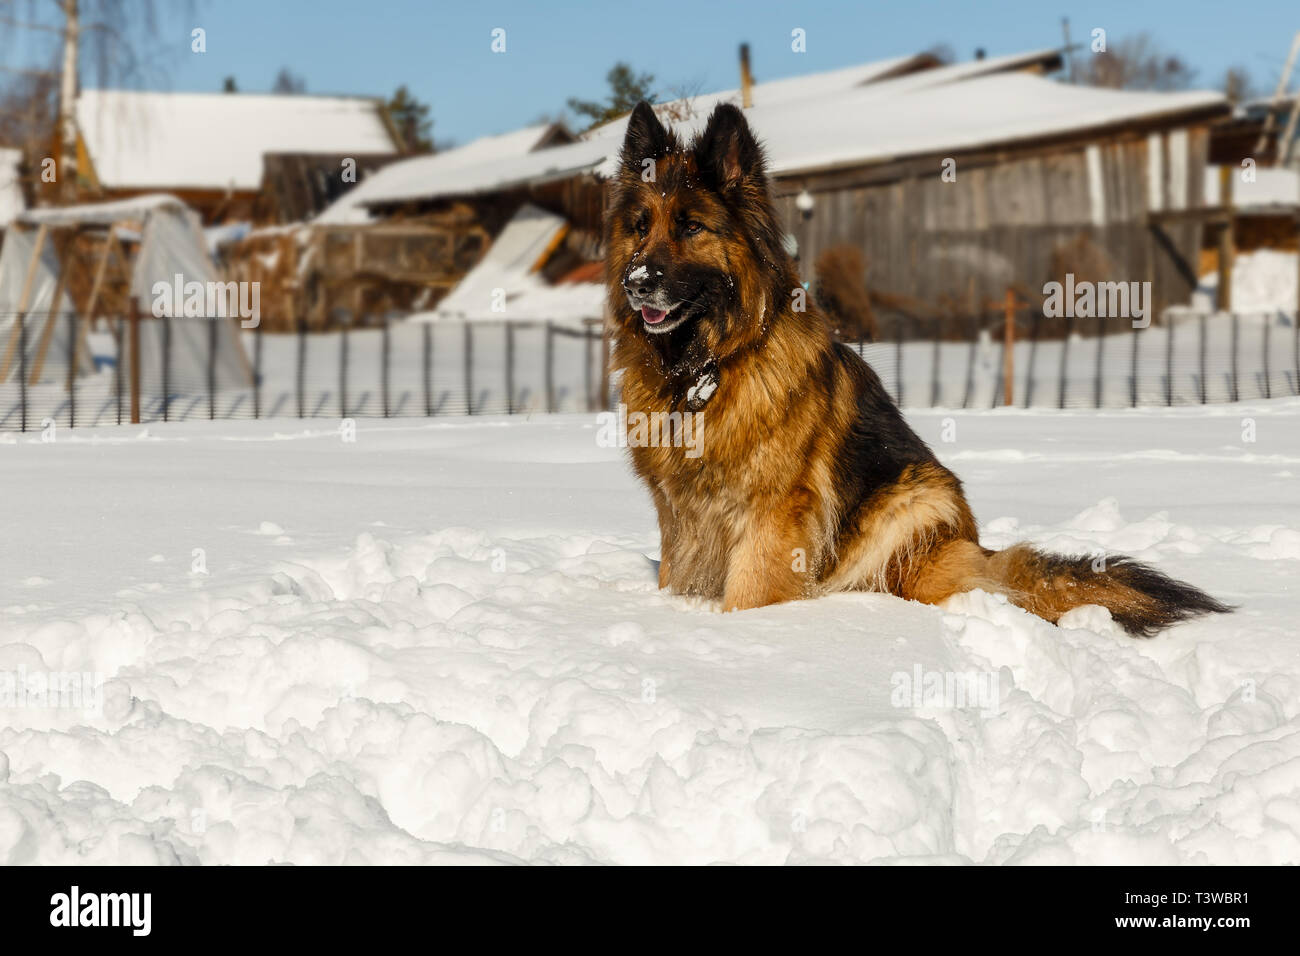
(7, 0), (1300, 143)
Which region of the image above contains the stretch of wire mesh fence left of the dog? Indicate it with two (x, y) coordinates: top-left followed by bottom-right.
(0, 312), (607, 431)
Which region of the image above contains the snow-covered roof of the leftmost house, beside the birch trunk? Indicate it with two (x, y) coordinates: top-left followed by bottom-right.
(77, 90), (397, 190)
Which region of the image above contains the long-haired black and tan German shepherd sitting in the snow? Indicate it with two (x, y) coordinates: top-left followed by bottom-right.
(605, 103), (1230, 636)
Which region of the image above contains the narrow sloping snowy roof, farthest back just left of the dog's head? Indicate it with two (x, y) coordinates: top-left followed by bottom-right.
(312, 124), (563, 225)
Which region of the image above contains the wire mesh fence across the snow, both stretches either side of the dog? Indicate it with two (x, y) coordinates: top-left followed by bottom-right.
(0, 308), (1300, 432)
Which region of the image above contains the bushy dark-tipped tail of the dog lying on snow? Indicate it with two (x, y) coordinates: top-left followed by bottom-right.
(976, 544), (1232, 637)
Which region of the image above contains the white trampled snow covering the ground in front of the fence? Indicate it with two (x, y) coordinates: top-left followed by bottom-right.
(0, 399), (1300, 864)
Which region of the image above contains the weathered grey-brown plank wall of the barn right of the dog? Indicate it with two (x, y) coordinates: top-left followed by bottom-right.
(775, 126), (1208, 325)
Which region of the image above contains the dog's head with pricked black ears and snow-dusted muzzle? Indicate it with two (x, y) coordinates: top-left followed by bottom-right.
(606, 103), (796, 376)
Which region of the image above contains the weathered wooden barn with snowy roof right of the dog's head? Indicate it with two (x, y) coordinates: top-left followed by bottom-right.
(753, 69), (1227, 329)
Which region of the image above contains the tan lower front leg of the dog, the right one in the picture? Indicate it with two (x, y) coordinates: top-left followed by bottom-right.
(723, 499), (811, 611)
